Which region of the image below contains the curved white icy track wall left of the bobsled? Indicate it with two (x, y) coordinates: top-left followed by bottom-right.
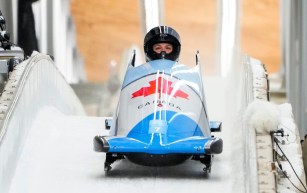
(0, 53), (85, 193)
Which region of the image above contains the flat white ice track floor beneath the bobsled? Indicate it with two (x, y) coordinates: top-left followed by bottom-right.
(10, 103), (241, 193)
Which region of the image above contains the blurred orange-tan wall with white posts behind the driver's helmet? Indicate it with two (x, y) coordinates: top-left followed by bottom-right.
(71, 0), (281, 81)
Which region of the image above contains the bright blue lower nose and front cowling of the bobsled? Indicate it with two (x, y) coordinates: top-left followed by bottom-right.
(103, 111), (210, 154)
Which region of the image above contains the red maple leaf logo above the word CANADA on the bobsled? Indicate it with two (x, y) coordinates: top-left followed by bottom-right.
(131, 77), (189, 99)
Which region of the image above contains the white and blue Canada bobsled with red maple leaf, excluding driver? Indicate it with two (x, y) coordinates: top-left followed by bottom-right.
(94, 53), (223, 173)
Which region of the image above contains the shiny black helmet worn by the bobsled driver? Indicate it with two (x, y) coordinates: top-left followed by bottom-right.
(144, 26), (181, 61)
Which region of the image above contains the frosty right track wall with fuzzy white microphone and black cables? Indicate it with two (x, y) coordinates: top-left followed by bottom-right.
(244, 57), (306, 193)
